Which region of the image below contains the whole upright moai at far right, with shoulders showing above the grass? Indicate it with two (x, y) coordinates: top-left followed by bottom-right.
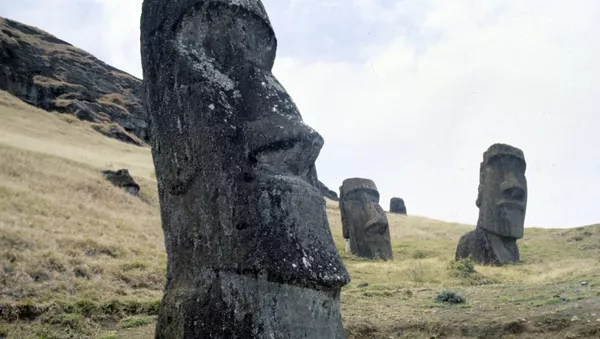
(456, 144), (527, 265)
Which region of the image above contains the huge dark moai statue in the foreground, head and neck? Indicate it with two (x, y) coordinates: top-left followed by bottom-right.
(141, 0), (350, 339)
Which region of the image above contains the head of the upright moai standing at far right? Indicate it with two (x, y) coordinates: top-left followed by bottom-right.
(476, 144), (527, 239)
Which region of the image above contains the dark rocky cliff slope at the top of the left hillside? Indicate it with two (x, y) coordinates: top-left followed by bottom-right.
(0, 17), (148, 145)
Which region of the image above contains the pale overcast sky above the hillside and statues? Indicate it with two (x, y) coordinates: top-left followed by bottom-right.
(0, 0), (600, 227)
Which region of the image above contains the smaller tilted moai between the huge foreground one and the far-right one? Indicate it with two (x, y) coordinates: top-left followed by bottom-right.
(340, 178), (392, 260)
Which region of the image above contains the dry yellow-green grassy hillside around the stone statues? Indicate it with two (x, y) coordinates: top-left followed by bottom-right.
(0, 92), (600, 339)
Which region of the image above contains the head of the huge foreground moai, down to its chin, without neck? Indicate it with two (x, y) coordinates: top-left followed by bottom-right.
(141, 0), (349, 288)
